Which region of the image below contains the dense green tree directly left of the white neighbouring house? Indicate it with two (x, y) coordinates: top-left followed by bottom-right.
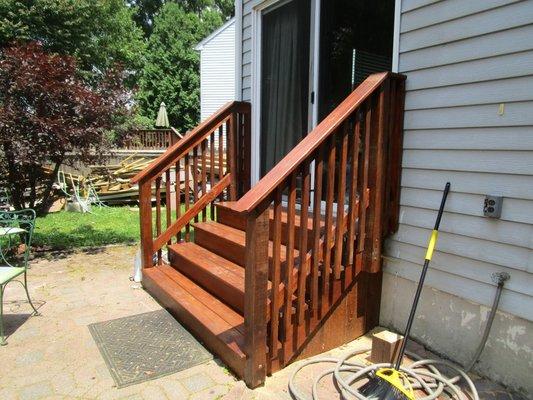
(137, 1), (224, 132)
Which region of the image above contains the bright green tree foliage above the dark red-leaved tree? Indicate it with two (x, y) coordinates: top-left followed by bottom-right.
(0, 0), (145, 82)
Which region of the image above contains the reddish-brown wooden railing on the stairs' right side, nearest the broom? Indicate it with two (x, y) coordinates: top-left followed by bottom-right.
(231, 73), (405, 387)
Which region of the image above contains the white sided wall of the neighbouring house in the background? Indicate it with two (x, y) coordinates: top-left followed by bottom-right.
(200, 21), (235, 121)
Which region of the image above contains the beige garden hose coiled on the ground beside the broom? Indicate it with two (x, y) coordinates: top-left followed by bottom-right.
(289, 348), (479, 400)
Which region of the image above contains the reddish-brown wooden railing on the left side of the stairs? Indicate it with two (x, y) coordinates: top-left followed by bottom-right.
(131, 101), (250, 268)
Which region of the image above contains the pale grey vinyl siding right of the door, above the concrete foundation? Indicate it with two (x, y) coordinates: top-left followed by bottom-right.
(385, 0), (533, 321)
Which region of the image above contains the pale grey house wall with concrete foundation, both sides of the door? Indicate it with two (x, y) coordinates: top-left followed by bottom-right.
(236, 0), (533, 394)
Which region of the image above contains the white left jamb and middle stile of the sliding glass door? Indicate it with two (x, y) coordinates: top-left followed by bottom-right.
(251, 0), (321, 186)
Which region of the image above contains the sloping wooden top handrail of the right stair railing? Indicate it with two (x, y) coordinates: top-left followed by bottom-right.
(234, 72), (405, 213)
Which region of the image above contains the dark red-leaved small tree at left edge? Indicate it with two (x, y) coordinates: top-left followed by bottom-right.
(0, 42), (127, 208)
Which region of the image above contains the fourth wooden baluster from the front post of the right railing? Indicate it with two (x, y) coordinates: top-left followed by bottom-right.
(311, 146), (324, 317)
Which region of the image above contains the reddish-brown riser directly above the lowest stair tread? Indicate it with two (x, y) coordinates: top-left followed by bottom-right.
(169, 250), (244, 313)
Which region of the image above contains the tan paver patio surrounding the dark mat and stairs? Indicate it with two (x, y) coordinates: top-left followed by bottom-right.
(0, 247), (518, 400)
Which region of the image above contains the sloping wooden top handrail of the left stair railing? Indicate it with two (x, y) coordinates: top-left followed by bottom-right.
(131, 101), (250, 184)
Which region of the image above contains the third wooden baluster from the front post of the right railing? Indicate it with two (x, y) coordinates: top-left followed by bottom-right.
(297, 160), (311, 325)
